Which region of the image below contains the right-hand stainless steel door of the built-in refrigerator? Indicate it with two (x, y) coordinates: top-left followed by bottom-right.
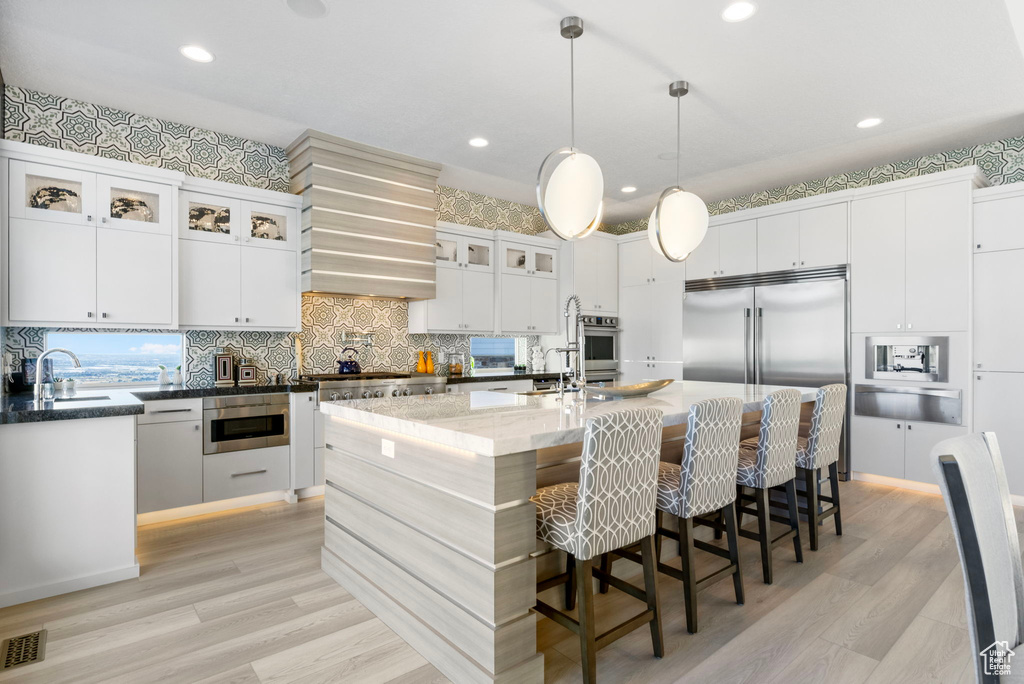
(754, 280), (847, 387)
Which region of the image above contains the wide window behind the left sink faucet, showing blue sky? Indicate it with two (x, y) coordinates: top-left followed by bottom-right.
(46, 333), (182, 385)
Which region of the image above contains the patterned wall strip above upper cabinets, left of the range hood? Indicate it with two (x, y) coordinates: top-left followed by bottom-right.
(4, 86), (289, 193)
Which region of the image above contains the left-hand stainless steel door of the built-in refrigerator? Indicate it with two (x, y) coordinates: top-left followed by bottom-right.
(684, 288), (754, 382)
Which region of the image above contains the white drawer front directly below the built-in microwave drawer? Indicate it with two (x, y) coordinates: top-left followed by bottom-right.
(203, 446), (291, 502)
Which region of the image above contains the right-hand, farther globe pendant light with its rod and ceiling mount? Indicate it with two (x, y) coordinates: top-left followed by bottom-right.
(647, 81), (709, 262)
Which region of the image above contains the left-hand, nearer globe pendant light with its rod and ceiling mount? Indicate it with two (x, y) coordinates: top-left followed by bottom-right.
(537, 16), (604, 240)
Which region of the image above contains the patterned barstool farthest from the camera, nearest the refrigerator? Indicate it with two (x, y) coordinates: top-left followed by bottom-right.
(797, 384), (846, 551)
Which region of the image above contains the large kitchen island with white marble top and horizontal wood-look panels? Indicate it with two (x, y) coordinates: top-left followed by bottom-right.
(322, 382), (815, 682)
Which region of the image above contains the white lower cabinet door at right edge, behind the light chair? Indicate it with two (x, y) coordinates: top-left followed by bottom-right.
(974, 372), (1024, 497)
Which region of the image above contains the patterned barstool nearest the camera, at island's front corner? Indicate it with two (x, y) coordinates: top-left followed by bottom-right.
(531, 409), (665, 682)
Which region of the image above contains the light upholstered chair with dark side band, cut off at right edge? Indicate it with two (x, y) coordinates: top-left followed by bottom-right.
(931, 432), (1024, 684)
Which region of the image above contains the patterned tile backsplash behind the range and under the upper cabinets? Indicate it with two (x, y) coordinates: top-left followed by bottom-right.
(4, 295), (539, 387)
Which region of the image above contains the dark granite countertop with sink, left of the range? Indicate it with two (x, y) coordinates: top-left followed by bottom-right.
(0, 383), (317, 425)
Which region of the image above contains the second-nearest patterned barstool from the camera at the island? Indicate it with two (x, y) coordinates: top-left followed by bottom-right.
(626, 398), (743, 634)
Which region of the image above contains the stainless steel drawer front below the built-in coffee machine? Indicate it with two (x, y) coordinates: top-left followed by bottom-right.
(853, 385), (963, 425)
